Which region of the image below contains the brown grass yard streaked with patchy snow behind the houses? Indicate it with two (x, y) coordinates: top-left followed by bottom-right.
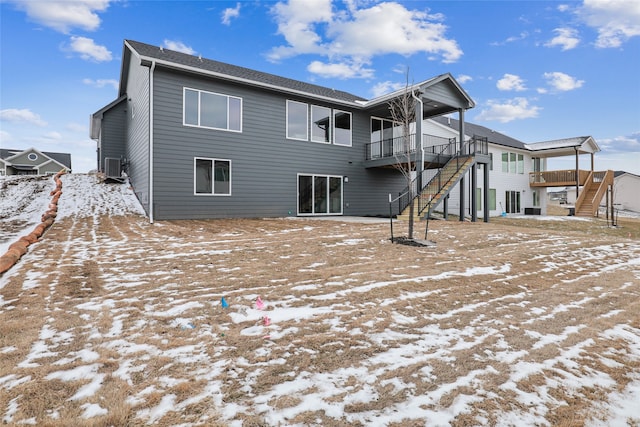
(0, 175), (640, 426)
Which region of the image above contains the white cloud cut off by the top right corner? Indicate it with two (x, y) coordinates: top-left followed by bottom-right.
(578, 0), (640, 48)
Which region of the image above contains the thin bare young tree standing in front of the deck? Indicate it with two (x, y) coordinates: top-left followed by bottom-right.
(389, 73), (417, 239)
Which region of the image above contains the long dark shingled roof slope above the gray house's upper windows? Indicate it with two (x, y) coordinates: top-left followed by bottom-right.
(125, 40), (366, 103)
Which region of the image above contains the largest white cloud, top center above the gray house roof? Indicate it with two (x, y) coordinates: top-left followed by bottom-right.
(268, 0), (462, 77)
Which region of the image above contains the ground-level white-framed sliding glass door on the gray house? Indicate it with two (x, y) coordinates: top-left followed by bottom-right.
(298, 175), (342, 215)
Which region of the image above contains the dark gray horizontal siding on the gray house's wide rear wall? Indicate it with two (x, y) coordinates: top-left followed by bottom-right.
(149, 68), (404, 220)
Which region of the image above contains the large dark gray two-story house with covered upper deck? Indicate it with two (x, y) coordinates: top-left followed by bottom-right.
(90, 40), (475, 222)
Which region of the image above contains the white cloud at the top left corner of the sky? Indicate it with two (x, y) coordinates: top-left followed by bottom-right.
(13, 0), (111, 34)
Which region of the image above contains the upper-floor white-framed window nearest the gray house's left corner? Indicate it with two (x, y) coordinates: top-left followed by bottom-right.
(183, 88), (242, 132)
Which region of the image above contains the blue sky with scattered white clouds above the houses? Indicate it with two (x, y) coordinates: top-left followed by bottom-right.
(0, 0), (640, 175)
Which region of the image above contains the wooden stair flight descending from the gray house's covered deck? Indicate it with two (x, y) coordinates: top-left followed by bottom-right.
(397, 156), (475, 220)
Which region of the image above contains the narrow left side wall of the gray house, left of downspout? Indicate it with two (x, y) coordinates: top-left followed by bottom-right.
(126, 57), (150, 213)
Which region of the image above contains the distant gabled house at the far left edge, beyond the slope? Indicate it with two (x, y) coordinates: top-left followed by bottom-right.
(0, 148), (71, 175)
